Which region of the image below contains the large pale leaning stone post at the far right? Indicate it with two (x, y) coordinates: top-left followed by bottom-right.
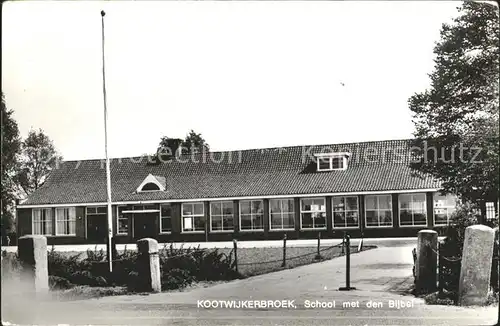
(458, 225), (495, 306)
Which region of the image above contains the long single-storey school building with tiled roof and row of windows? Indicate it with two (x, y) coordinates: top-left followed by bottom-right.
(16, 140), (464, 244)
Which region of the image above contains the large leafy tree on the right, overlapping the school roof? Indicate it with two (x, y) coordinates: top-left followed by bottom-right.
(408, 2), (500, 216)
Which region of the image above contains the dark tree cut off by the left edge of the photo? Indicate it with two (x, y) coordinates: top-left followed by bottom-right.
(1, 93), (20, 238)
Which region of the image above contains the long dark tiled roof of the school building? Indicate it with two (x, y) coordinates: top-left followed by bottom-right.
(23, 140), (439, 205)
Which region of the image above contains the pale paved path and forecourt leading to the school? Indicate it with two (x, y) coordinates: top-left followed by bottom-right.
(2, 245), (497, 325)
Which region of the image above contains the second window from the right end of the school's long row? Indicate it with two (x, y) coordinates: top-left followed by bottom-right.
(399, 194), (427, 226)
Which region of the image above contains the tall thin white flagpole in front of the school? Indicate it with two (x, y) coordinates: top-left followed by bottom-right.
(101, 10), (113, 272)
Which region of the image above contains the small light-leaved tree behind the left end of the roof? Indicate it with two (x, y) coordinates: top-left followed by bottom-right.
(16, 129), (62, 194)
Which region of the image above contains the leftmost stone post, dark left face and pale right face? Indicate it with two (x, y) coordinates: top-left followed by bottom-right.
(17, 235), (49, 293)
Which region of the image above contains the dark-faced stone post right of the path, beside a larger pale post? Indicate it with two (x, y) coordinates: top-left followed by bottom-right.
(415, 230), (438, 293)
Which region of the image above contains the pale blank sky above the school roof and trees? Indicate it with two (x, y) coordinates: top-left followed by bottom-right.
(2, 1), (460, 160)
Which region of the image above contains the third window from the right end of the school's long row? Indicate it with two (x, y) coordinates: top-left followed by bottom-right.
(365, 195), (392, 227)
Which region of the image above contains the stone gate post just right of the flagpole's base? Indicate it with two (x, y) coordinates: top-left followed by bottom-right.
(137, 238), (161, 292)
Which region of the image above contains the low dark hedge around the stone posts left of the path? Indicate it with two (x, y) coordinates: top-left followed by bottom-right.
(9, 245), (240, 291)
